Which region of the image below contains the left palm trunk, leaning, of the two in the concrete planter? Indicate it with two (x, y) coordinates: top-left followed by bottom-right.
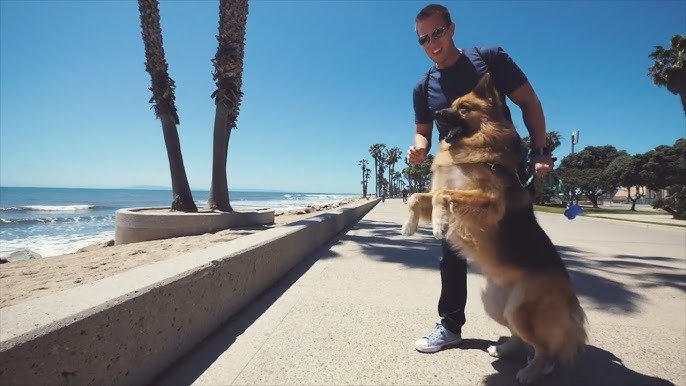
(138, 0), (198, 212)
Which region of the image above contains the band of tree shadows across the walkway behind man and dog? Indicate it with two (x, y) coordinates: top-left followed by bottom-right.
(352, 219), (686, 313)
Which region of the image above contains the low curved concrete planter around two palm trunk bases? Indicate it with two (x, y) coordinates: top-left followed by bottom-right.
(114, 207), (274, 245)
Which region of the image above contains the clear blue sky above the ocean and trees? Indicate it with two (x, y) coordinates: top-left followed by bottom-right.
(0, 0), (686, 193)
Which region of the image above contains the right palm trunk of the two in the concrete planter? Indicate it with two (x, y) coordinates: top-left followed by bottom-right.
(207, 0), (248, 212)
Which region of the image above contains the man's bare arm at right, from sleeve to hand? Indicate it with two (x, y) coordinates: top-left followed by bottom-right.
(508, 82), (553, 175)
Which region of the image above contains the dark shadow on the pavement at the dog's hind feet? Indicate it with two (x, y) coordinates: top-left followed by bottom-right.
(456, 337), (674, 386)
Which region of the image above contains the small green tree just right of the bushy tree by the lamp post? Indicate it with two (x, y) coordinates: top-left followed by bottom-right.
(605, 153), (647, 210)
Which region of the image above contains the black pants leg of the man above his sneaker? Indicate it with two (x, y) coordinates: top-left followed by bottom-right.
(438, 240), (467, 334)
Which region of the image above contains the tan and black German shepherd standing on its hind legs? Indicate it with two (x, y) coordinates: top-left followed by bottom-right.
(402, 74), (587, 383)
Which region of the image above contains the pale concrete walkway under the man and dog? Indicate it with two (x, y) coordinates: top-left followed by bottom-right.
(157, 199), (686, 386)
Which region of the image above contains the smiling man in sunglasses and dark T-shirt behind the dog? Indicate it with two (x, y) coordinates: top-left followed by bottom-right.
(408, 4), (552, 353)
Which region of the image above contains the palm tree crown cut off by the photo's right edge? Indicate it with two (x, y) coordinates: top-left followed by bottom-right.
(648, 35), (686, 114)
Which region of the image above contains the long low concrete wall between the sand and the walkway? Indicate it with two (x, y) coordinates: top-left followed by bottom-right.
(0, 200), (378, 385)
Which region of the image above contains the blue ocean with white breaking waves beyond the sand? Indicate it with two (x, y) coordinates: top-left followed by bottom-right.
(0, 187), (357, 257)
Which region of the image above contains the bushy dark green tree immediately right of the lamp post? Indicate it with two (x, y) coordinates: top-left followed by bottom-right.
(557, 145), (620, 208)
